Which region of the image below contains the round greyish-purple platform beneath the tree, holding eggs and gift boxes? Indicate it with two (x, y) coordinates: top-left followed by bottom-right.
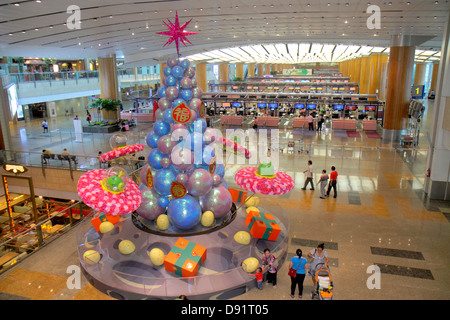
(78, 208), (289, 300)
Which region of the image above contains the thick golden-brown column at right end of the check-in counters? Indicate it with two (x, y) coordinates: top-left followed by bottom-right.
(383, 36), (415, 140)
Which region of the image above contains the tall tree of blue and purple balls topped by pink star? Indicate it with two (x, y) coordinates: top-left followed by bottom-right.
(136, 15), (232, 231)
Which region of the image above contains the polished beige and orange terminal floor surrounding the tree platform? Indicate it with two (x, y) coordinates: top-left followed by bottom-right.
(0, 101), (450, 300)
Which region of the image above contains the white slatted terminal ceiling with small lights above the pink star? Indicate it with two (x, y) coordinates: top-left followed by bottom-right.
(0, 0), (450, 65)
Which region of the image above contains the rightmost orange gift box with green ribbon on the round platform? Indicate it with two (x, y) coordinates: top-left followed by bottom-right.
(245, 211), (281, 241)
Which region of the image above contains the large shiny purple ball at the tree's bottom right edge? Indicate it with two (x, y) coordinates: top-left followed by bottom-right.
(199, 187), (233, 219)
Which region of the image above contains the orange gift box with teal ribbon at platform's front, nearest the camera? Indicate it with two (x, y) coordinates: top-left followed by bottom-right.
(164, 238), (206, 277)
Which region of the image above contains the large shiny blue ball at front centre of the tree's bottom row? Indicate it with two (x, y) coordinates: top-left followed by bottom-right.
(167, 195), (202, 230)
